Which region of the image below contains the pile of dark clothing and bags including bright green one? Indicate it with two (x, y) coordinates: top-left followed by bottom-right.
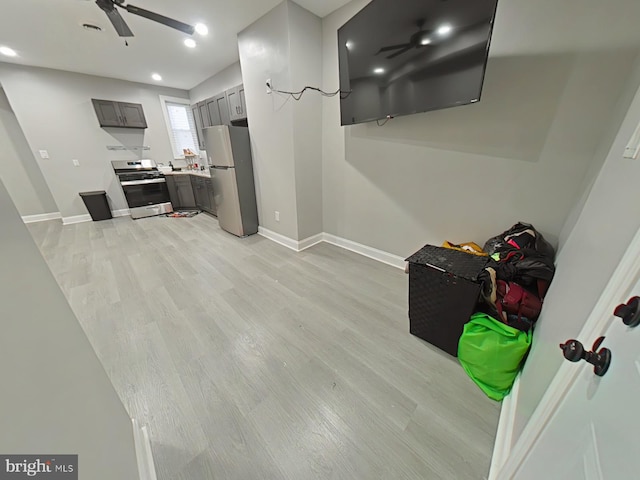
(456, 223), (555, 400)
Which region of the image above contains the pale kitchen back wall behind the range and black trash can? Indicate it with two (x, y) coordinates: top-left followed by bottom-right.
(0, 63), (188, 217)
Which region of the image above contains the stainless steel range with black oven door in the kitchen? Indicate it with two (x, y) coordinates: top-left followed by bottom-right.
(111, 160), (173, 218)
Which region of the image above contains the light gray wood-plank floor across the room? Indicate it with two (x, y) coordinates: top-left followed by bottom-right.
(29, 214), (499, 480)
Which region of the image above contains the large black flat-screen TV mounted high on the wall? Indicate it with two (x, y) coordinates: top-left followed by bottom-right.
(338, 0), (497, 125)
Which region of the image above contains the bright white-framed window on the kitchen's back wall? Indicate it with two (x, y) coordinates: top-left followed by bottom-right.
(160, 96), (199, 158)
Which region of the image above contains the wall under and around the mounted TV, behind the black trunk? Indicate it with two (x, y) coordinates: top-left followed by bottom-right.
(323, 0), (637, 256)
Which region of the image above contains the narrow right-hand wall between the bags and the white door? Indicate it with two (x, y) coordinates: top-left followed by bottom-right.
(514, 60), (640, 442)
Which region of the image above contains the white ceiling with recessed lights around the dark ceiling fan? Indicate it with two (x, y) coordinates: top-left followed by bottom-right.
(0, 0), (349, 90)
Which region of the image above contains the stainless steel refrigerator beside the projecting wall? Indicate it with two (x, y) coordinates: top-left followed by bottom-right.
(204, 125), (258, 237)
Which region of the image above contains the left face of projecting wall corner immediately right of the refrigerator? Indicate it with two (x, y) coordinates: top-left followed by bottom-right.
(238, 2), (298, 238)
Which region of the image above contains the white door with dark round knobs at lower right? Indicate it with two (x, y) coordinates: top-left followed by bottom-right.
(498, 246), (640, 480)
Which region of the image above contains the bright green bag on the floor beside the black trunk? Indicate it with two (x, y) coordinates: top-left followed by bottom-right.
(458, 313), (531, 401)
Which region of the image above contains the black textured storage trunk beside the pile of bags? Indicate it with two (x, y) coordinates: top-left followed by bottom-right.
(407, 245), (488, 357)
